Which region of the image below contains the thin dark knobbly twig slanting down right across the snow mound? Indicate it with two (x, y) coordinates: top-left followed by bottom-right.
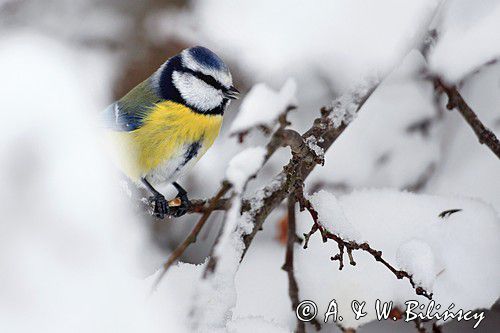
(299, 195), (432, 299)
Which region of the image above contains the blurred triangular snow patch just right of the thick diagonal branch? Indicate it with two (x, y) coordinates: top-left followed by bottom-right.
(308, 51), (444, 189)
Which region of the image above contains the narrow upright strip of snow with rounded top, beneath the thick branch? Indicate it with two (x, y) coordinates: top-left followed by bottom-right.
(193, 147), (266, 331)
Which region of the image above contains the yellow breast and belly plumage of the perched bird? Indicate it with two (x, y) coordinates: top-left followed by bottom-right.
(108, 101), (222, 182)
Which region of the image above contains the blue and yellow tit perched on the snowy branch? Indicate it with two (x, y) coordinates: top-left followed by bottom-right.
(102, 46), (240, 219)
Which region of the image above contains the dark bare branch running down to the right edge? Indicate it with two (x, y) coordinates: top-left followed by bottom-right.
(433, 77), (500, 158)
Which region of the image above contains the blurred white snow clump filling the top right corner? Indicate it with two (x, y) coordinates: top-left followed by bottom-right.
(429, 0), (500, 83)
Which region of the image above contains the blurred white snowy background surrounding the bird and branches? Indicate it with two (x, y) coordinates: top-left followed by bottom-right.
(0, 0), (500, 332)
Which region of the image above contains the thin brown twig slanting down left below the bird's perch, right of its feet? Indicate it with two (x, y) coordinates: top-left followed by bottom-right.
(154, 181), (232, 289)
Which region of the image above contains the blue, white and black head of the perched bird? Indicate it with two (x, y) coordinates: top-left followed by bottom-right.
(153, 46), (239, 114)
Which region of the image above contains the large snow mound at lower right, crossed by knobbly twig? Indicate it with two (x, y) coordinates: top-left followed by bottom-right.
(295, 190), (500, 328)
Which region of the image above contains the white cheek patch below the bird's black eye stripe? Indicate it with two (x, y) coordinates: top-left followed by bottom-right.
(172, 71), (223, 111)
